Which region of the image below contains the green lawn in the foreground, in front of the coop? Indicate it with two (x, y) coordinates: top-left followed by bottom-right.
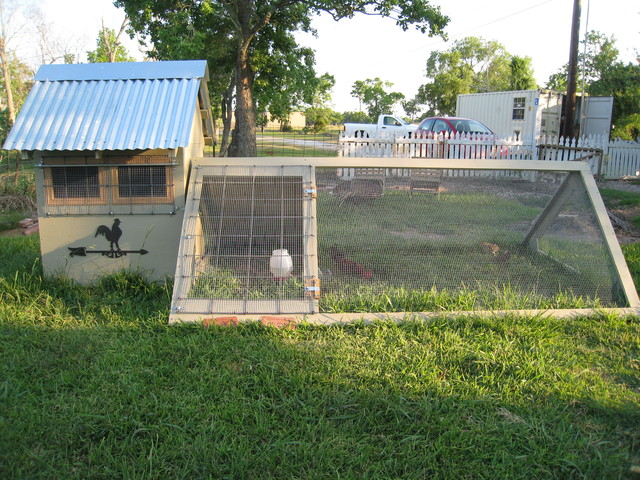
(0, 237), (640, 480)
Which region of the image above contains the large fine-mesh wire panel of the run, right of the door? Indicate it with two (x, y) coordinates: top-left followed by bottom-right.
(316, 167), (629, 313)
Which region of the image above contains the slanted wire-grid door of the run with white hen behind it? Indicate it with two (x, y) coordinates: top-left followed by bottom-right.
(171, 166), (319, 320)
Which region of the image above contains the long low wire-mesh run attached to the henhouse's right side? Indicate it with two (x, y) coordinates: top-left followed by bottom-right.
(172, 159), (638, 321)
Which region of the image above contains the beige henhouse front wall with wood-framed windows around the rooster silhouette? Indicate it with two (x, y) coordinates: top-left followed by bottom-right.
(35, 149), (190, 283)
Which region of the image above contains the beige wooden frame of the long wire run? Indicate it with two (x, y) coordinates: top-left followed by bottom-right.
(169, 157), (640, 324)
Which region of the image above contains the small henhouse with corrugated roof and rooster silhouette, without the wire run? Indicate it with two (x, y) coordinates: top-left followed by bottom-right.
(4, 61), (212, 282)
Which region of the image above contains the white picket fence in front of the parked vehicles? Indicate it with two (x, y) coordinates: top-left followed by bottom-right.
(338, 133), (640, 179)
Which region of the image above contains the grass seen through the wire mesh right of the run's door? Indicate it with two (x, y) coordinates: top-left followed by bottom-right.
(317, 189), (626, 313)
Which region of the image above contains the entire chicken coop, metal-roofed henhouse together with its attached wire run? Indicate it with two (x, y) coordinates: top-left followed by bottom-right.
(4, 61), (640, 323)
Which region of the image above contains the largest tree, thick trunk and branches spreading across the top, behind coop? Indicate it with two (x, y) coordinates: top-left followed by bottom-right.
(115, 0), (448, 156)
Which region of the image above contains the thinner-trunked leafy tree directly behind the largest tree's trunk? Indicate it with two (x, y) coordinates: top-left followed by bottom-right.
(114, 0), (315, 156)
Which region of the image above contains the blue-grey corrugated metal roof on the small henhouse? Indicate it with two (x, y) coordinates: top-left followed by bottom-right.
(3, 61), (207, 150)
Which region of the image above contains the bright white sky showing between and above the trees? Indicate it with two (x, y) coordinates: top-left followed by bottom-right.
(19, 0), (640, 113)
